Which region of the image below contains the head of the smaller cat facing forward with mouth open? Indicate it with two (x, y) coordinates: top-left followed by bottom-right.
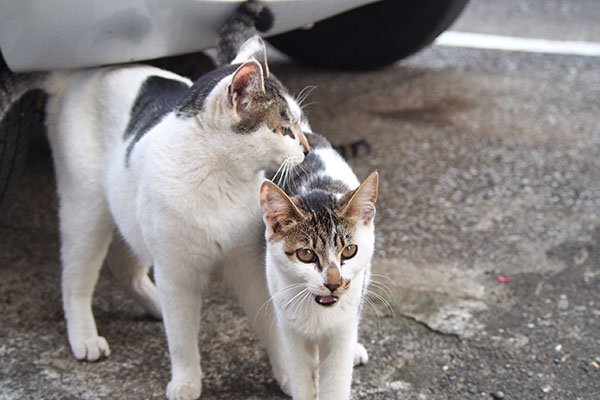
(260, 172), (378, 306)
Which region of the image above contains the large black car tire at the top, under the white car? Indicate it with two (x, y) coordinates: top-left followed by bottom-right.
(268, 0), (468, 70)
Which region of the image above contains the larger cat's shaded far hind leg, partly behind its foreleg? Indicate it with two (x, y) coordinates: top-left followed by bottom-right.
(106, 233), (162, 319)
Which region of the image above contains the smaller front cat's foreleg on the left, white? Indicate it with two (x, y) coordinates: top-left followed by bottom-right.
(280, 326), (318, 400)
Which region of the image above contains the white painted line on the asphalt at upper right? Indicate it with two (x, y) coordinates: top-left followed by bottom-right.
(435, 31), (600, 57)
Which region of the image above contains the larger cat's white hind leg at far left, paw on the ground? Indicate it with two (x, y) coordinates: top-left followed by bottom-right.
(59, 184), (114, 361)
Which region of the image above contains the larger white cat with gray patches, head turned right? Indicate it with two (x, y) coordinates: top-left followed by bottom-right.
(46, 37), (308, 399)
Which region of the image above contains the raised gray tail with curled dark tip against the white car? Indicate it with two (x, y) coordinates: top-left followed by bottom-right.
(217, 0), (274, 65)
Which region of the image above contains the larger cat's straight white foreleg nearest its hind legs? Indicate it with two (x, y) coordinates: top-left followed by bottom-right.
(155, 264), (204, 400)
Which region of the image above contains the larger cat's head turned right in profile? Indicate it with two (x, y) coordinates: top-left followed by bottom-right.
(178, 36), (309, 168)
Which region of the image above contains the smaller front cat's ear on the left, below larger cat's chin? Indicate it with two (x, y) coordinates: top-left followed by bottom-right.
(260, 181), (304, 234)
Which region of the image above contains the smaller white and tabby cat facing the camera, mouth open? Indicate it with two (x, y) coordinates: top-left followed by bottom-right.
(260, 132), (378, 400)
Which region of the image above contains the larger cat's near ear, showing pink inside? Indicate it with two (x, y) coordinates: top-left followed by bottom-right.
(227, 60), (265, 112)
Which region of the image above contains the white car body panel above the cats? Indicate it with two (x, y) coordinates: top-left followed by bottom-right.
(0, 0), (376, 72)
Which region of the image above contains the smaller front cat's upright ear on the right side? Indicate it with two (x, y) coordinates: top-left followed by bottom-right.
(340, 171), (379, 225)
